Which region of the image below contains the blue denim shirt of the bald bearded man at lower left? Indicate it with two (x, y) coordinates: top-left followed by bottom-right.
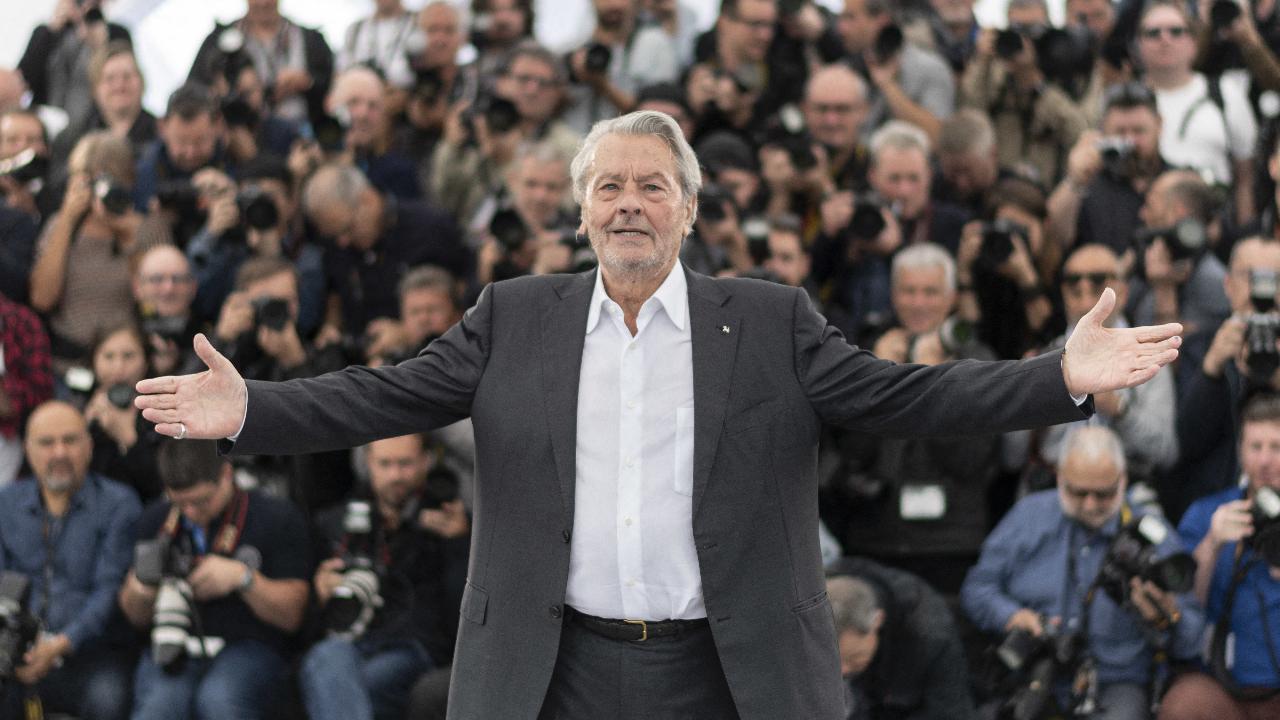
(0, 473), (141, 651)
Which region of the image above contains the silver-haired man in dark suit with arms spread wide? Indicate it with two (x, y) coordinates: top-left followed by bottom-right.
(138, 111), (1180, 720)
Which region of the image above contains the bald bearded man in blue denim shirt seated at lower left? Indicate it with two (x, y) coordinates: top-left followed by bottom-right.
(0, 401), (141, 720)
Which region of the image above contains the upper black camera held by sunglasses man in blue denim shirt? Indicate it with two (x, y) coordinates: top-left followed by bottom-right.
(1094, 515), (1196, 605)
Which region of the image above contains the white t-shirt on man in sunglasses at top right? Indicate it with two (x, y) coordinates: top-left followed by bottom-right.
(1156, 73), (1258, 184)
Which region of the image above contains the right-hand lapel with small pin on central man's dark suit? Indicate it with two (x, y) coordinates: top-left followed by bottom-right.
(685, 269), (742, 516)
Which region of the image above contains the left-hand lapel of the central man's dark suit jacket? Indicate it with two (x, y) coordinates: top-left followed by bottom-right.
(540, 272), (595, 527)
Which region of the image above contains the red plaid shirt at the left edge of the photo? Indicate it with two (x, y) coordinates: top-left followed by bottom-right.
(0, 295), (54, 438)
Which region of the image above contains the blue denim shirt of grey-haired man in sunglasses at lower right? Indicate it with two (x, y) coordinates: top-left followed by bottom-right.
(960, 489), (1204, 683)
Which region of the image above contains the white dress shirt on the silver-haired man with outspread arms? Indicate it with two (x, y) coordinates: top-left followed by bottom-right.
(566, 263), (707, 620)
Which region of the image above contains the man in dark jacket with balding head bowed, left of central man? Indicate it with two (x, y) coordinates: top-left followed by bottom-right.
(302, 165), (470, 337)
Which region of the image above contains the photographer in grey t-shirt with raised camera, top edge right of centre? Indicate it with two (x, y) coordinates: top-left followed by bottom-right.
(836, 0), (956, 142)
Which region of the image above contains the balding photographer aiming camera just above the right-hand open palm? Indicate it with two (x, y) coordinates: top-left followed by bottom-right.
(1126, 170), (1231, 333)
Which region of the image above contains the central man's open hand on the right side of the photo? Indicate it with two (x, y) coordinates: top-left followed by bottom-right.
(1062, 287), (1183, 396)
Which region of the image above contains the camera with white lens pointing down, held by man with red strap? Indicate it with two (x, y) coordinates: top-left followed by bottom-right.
(133, 534), (196, 673)
